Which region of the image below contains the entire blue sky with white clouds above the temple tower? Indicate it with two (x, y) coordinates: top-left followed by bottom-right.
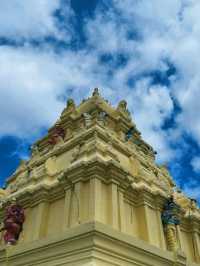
(0, 0), (200, 200)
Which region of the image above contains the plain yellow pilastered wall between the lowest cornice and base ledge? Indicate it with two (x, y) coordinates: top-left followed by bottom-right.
(0, 177), (200, 262)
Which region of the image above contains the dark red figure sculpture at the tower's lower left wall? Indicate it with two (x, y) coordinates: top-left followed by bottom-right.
(3, 203), (25, 245)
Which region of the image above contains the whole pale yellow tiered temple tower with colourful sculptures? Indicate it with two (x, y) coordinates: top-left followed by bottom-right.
(0, 89), (200, 266)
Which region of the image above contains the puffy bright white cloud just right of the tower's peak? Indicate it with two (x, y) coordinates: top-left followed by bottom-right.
(124, 79), (174, 162)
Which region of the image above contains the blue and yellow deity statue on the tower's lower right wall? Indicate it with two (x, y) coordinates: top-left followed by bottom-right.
(161, 197), (180, 251)
